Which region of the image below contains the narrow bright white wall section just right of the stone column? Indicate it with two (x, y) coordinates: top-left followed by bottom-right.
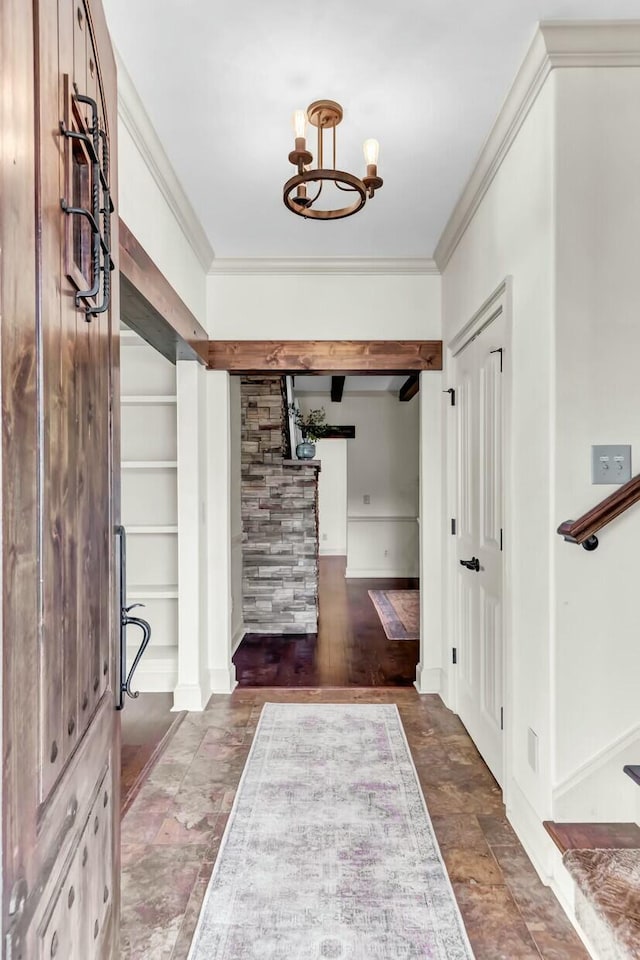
(315, 438), (350, 557)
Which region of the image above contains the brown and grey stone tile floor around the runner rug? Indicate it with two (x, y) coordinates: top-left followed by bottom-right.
(121, 688), (589, 960)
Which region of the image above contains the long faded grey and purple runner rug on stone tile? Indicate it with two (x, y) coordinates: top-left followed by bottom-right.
(189, 703), (473, 960)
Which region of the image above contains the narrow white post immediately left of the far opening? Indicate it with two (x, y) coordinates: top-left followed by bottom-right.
(205, 370), (236, 693)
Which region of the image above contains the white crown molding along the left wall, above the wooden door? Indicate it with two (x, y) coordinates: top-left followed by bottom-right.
(116, 51), (214, 272)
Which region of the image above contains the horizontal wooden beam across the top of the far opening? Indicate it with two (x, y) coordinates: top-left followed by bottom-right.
(207, 340), (442, 376)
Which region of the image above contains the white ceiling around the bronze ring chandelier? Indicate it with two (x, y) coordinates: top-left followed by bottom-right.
(104, 0), (640, 257)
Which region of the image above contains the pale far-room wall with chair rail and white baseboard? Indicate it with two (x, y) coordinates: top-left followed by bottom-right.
(298, 392), (420, 577)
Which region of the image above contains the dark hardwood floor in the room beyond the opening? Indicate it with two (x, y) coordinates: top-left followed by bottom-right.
(233, 557), (420, 687)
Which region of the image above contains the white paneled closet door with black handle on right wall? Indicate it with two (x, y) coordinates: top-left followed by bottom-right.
(454, 316), (504, 783)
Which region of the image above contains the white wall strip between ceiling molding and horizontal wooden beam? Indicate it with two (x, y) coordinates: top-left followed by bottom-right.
(207, 272), (440, 340)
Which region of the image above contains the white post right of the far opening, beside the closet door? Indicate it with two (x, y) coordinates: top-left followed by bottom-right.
(415, 372), (444, 693)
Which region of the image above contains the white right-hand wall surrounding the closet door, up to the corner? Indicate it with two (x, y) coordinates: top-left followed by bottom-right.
(441, 74), (556, 831)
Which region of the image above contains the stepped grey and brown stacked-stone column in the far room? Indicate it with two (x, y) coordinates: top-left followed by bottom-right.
(241, 377), (319, 634)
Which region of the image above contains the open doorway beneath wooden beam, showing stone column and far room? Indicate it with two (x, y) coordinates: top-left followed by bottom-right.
(234, 375), (420, 686)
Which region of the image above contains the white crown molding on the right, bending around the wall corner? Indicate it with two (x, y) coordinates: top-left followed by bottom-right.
(434, 20), (640, 271)
